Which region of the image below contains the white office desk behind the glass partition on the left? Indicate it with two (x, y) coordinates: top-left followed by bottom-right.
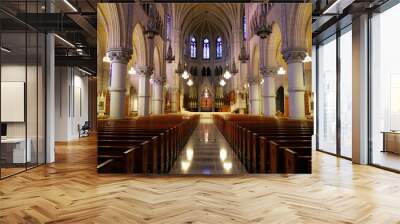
(1, 138), (32, 163)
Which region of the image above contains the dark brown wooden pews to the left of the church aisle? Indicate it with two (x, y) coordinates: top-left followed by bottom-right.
(97, 115), (199, 174)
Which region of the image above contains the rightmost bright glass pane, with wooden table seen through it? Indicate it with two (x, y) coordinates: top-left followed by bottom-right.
(370, 4), (400, 170)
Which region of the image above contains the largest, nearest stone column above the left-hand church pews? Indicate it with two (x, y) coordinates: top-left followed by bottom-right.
(107, 48), (132, 119)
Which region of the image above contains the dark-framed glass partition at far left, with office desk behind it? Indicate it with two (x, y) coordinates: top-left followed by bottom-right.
(0, 1), (46, 178)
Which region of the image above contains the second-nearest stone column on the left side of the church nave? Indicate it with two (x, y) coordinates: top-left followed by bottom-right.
(136, 65), (153, 116)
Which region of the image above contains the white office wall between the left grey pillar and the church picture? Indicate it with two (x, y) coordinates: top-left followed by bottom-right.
(55, 67), (89, 141)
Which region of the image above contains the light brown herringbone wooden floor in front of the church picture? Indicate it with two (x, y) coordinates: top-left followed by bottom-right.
(0, 136), (400, 224)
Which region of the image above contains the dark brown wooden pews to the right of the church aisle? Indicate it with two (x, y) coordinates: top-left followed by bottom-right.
(213, 114), (313, 173)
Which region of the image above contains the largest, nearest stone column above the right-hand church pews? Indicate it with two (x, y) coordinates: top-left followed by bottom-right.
(284, 49), (306, 119)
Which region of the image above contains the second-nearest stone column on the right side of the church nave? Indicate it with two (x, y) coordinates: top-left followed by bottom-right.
(261, 67), (276, 116)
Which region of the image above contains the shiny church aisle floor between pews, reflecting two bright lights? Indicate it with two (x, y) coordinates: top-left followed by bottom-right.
(170, 116), (247, 175)
